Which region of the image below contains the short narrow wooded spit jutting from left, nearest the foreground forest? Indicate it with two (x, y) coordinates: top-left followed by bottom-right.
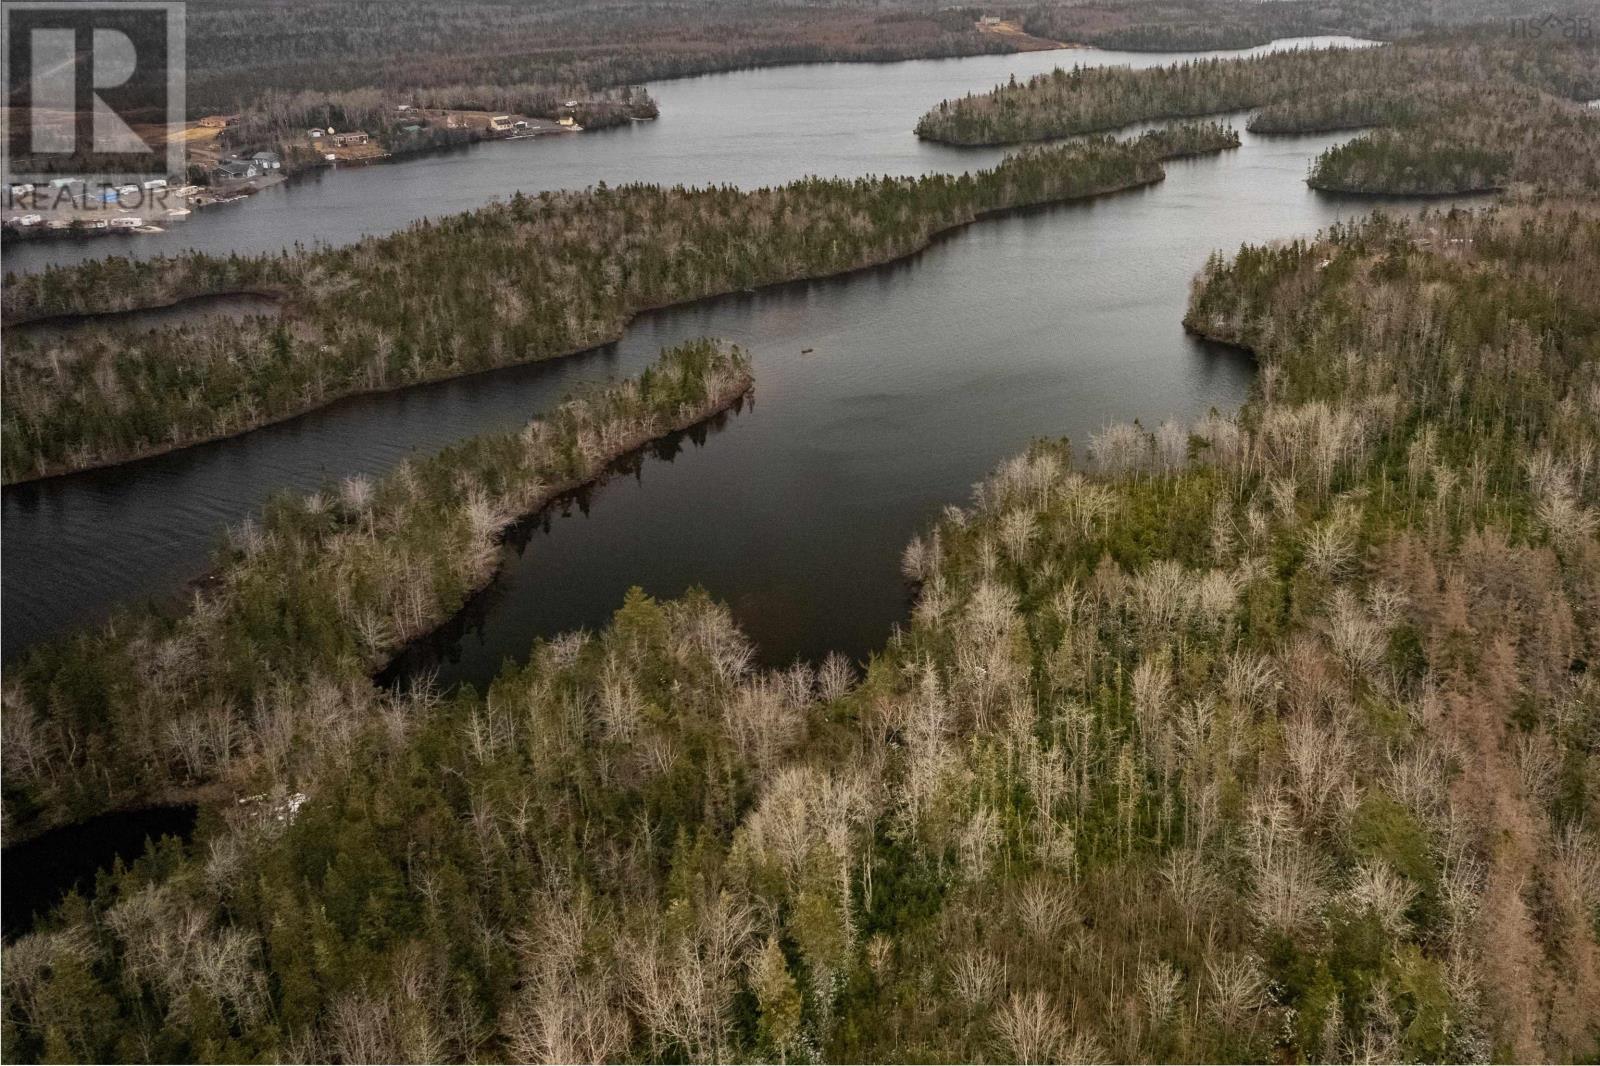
(3, 341), (752, 839)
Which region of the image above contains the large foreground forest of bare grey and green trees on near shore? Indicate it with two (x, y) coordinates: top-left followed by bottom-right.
(3, 202), (1600, 1061)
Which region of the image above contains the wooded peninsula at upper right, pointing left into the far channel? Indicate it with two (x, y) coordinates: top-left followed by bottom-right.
(917, 27), (1600, 195)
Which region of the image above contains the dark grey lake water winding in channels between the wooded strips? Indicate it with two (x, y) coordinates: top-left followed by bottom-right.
(3, 37), (1465, 682)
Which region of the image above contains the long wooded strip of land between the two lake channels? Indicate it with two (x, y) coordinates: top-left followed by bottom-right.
(3, 125), (1238, 480)
